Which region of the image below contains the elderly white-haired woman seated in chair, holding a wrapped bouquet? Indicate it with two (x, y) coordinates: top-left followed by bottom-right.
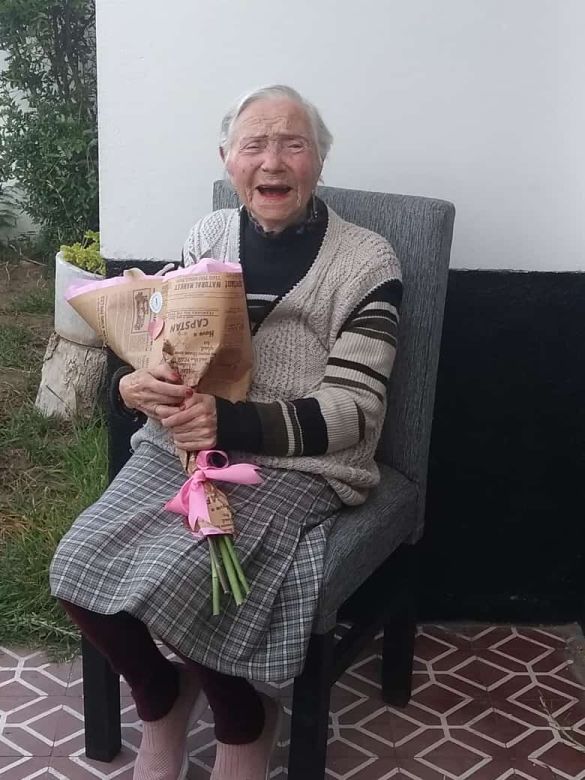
(51, 86), (401, 780)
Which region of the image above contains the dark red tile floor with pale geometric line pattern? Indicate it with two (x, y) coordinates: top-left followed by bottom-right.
(0, 626), (585, 780)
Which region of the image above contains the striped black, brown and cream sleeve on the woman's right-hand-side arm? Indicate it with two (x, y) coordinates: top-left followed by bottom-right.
(217, 280), (402, 456)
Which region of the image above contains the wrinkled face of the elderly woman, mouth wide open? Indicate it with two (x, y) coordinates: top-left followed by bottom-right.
(222, 99), (321, 232)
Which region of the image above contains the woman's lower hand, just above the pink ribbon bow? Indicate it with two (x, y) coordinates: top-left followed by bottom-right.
(159, 393), (217, 452)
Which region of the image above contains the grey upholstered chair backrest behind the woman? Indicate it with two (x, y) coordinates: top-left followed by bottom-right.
(213, 181), (455, 524)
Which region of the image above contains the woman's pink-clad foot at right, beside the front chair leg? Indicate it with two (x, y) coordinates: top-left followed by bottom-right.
(210, 694), (282, 780)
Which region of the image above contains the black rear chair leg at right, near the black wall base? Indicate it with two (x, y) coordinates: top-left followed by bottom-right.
(382, 589), (416, 707)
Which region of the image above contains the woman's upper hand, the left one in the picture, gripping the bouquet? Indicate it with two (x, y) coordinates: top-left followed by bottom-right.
(119, 363), (193, 421)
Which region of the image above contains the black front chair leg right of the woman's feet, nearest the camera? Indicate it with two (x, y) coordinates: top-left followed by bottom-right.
(288, 631), (333, 780)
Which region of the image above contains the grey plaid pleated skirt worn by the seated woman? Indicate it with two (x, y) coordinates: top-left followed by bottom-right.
(50, 442), (341, 682)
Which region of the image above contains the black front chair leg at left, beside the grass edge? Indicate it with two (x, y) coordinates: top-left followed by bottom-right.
(81, 638), (122, 761)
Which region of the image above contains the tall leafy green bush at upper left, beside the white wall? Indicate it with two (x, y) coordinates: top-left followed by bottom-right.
(0, 0), (98, 248)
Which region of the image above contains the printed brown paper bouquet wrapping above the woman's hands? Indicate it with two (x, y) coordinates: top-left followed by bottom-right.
(69, 269), (252, 401)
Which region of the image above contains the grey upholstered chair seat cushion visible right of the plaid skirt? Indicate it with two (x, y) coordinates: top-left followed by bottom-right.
(313, 465), (418, 634)
